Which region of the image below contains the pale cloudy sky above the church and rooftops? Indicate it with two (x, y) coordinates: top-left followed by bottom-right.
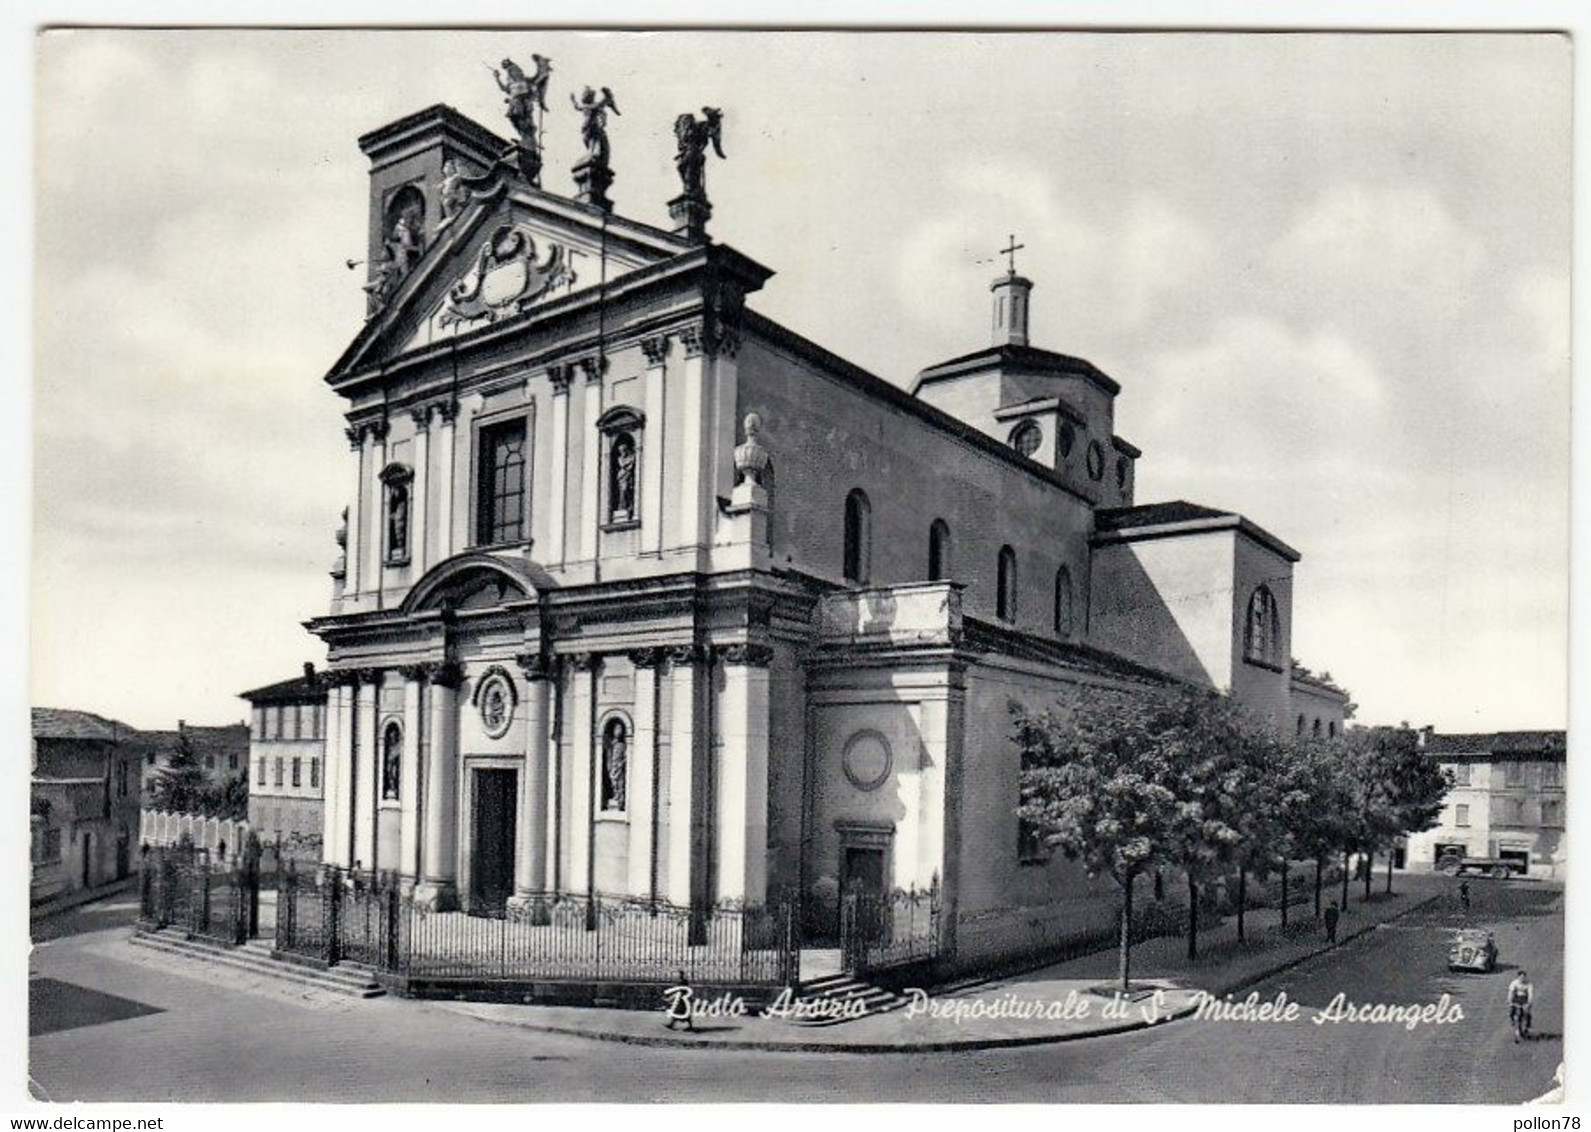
(30, 30), (1572, 731)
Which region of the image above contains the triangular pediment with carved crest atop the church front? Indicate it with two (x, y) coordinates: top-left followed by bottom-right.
(331, 188), (692, 378)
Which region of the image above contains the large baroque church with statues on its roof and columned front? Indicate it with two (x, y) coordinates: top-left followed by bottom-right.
(309, 86), (1346, 959)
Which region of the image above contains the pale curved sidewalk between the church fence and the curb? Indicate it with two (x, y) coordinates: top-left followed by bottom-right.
(442, 876), (1449, 1054)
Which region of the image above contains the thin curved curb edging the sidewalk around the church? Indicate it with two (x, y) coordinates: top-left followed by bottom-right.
(444, 894), (1443, 1056)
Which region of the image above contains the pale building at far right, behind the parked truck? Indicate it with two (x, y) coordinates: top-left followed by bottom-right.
(1408, 730), (1569, 876)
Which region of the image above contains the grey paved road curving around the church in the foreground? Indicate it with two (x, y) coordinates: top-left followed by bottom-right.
(30, 882), (1564, 1102)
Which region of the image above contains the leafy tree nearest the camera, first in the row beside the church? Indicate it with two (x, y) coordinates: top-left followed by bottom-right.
(1010, 687), (1177, 991)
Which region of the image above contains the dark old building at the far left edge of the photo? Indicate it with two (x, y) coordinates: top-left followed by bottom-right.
(29, 708), (145, 903)
